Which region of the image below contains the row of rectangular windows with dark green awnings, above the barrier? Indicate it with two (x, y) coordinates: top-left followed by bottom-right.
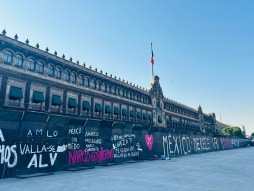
(1, 77), (153, 124)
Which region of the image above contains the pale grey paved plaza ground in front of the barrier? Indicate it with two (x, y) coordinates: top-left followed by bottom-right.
(0, 147), (254, 191)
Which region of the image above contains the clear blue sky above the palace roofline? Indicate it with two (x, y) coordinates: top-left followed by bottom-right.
(0, 0), (254, 134)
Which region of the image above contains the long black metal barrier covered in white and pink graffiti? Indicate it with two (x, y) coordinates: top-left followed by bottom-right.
(0, 111), (248, 178)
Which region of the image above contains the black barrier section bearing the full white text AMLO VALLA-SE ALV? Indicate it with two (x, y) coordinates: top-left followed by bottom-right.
(16, 112), (69, 175)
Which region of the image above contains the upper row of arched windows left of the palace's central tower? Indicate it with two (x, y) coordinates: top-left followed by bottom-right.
(0, 49), (149, 104)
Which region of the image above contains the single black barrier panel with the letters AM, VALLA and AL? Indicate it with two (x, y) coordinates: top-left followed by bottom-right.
(16, 112), (49, 176)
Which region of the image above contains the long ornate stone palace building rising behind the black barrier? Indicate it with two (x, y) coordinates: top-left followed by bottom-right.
(0, 31), (225, 134)
